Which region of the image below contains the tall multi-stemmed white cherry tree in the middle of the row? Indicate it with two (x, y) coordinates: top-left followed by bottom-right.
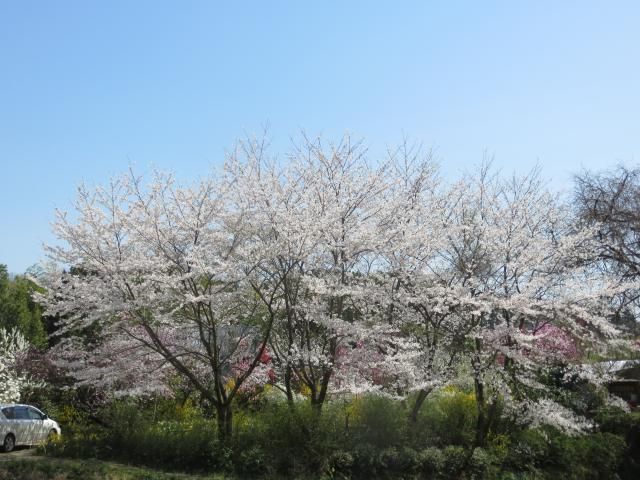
(231, 137), (400, 411)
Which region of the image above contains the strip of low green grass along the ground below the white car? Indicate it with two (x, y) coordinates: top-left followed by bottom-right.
(0, 456), (232, 480)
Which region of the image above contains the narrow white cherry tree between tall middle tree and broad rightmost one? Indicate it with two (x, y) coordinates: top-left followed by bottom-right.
(350, 143), (455, 417)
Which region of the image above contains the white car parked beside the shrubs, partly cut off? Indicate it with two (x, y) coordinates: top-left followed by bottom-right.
(0, 404), (61, 452)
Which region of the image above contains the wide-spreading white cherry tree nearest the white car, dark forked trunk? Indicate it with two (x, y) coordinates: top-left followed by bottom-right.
(45, 173), (274, 437)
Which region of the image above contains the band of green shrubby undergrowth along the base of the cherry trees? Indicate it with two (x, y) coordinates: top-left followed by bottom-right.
(44, 389), (640, 480)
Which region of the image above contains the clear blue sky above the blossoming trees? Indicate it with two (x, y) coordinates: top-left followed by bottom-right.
(0, 0), (640, 273)
